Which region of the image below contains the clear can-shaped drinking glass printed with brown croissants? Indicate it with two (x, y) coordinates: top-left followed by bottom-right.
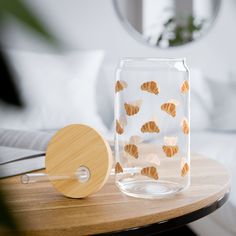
(114, 58), (190, 198)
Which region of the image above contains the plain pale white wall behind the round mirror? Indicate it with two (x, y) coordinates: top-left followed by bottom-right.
(3, 0), (236, 79)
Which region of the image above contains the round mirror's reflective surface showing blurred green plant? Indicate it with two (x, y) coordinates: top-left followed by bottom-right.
(113, 0), (221, 48)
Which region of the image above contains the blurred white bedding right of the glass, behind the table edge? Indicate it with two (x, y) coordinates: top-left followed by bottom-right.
(190, 131), (236, 236)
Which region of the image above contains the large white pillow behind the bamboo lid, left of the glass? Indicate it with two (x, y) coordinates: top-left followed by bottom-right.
(0, 50), (105, 135)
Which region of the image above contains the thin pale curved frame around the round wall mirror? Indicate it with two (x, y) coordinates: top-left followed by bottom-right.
(112, 0), (222, 50)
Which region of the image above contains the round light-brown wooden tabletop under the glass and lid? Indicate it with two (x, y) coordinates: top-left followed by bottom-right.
(0, 156), (230, 236)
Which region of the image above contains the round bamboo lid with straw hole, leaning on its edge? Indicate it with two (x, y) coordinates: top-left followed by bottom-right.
(45, 124), (112, 198)
